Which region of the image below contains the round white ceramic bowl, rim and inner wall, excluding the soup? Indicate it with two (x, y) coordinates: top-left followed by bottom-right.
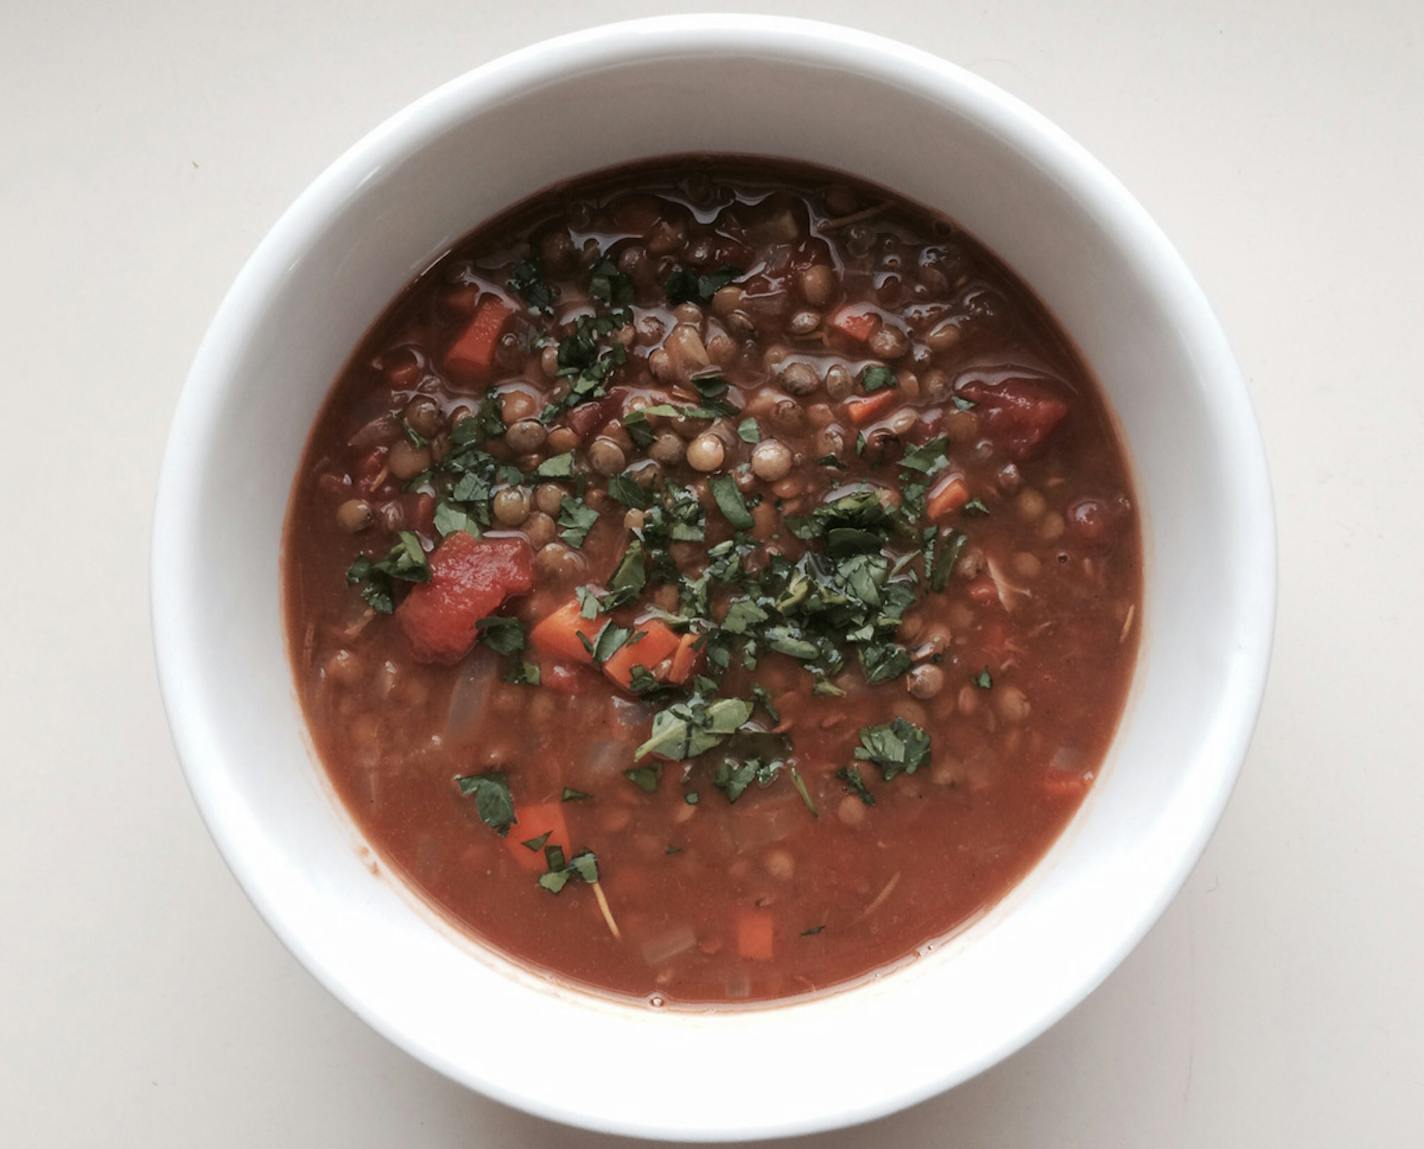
(152, 16), (1274, 1140)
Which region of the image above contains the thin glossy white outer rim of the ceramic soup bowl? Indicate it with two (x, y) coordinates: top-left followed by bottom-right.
(150, 14), (1277, 1140)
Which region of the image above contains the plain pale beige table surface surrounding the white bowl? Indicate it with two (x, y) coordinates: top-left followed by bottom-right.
(0, 0), (1424, 1149)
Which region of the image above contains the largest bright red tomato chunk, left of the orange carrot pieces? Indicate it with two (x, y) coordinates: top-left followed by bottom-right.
(396, 531), (534, 665)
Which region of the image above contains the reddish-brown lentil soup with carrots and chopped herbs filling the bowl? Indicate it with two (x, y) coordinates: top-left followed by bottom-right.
(283, 158), (1141, 1004)
